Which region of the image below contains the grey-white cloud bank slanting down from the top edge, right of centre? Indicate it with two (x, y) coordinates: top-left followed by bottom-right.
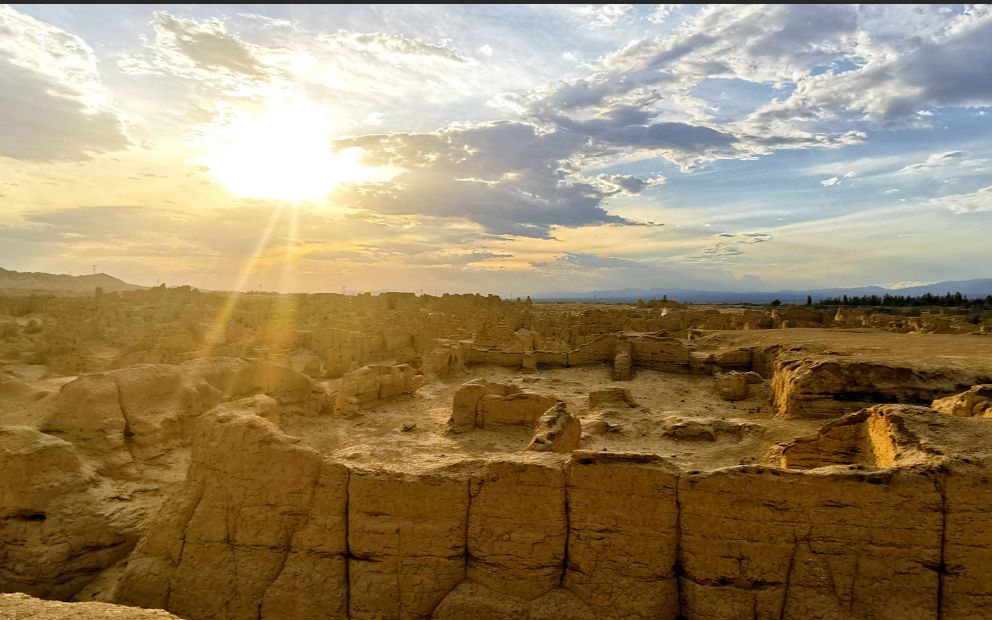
(531, 5), (866, 170)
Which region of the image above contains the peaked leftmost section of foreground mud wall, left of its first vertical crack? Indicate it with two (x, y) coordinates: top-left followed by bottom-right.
(116, 411), (350, 620)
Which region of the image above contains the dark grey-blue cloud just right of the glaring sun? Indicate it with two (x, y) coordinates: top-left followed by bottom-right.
(338, 122), (640, 237)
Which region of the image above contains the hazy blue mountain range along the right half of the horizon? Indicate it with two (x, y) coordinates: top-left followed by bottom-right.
(532, 278), (992, 304)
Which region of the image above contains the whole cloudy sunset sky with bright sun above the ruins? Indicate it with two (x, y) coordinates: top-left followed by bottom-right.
(0, 4), (992, 297)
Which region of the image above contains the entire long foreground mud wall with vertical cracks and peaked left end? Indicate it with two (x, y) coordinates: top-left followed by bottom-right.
(117, 413), (992, 620)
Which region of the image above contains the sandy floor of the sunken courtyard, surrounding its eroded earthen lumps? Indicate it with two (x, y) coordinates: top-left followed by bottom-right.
(282, 365), (823, 470)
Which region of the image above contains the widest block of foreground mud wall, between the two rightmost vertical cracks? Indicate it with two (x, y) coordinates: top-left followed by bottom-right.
(678, 467), (944, 619)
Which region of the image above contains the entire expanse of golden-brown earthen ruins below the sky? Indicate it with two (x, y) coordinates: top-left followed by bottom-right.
(0, 287), (992, 620)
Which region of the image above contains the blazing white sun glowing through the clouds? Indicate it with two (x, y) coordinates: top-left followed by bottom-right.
(198, 101), (371, 201)
